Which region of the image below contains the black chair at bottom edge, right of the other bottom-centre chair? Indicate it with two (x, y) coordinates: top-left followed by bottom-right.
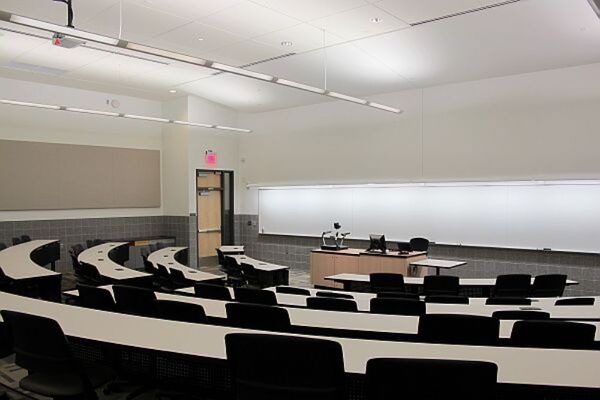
(366, 358), (498, 400)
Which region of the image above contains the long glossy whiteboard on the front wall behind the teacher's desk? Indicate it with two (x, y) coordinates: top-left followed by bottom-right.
(258, 181), (600, 253)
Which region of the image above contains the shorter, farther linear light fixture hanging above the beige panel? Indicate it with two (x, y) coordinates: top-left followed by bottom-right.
(0, 99), (252, 133)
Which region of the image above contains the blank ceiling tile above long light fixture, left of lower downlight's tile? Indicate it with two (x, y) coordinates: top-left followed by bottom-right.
(149, 22), (245, 57)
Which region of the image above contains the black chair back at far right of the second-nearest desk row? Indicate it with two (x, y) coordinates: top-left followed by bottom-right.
(510, 320), (596, 349)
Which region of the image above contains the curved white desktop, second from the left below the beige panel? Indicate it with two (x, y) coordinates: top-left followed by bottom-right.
(77, 242), (152, 281)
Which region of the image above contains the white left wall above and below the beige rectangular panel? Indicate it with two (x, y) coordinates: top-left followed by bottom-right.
(0, 78), (163, 221)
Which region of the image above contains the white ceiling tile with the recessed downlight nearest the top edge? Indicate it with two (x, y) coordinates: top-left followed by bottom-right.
(311, 5), (409, 40)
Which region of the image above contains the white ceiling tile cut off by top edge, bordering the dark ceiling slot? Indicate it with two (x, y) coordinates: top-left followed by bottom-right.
(375, 0), (500, 24)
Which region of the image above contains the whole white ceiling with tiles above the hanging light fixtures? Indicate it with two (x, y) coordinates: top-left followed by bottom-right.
(0, 0), (600, 112)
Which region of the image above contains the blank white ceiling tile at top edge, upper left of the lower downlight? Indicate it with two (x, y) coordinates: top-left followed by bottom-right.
(200, 1), (298, 37)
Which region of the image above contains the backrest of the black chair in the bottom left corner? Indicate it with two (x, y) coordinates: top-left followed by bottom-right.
(0, 310), (77, 372)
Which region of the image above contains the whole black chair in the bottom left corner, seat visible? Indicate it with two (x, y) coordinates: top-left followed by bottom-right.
(0, 310), (115, 399)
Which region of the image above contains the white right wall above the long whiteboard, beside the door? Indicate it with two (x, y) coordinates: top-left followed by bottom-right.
(238, 64), (600, 214)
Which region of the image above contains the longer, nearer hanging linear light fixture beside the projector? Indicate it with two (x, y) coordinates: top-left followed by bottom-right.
(0, 11), (401, 113)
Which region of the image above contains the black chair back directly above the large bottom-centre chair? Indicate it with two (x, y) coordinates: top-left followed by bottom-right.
(225, 303), (291, 332)
